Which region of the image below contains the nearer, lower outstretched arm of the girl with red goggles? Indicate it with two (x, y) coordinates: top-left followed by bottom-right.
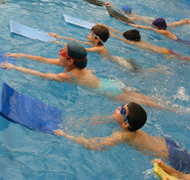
(1, 63), (72, 82)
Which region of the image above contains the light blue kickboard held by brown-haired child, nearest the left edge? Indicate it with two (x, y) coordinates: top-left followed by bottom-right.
(10, 21), (56, 42)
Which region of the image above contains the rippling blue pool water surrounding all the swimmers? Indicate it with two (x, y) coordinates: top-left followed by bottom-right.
(0, 0), (190, 180)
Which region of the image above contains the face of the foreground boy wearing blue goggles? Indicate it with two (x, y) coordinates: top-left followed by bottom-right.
(112, 104), (129, 124)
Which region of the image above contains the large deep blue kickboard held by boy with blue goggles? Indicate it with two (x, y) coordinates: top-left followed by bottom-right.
(0, 83), (62, 134)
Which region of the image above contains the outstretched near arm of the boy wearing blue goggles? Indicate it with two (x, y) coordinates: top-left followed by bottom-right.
(53, 129), (122, 151)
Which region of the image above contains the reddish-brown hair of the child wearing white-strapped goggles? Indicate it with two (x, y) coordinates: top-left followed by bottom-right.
(91, 25), (110, 45)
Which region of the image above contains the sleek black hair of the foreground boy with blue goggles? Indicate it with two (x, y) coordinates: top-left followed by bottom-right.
(127, 102), (147, 131)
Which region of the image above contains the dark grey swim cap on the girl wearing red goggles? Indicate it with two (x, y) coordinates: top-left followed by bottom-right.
(67, 42), (88, 69)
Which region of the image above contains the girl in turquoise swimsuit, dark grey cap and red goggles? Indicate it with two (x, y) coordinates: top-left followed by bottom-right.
(1, 42), (170, 110)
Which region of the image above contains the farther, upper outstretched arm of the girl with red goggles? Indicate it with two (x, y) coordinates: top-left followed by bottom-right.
(5, 53), (59, 65)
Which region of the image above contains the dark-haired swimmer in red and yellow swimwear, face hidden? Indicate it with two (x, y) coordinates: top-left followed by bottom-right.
(97, 25), (190, 61)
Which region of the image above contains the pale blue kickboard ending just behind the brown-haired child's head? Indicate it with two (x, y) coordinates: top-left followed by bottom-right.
(63, 14), (95, 29)
